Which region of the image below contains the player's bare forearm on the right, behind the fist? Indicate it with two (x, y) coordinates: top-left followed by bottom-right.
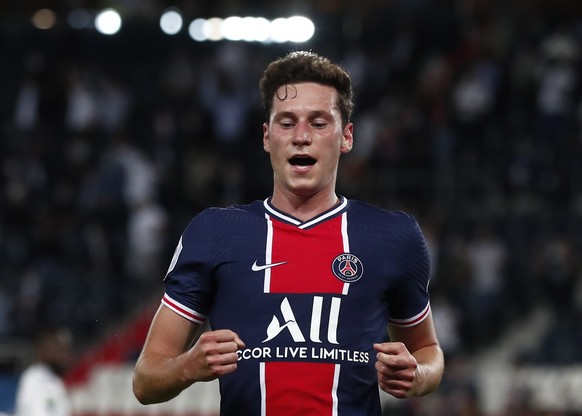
(411, 344), (445, 396)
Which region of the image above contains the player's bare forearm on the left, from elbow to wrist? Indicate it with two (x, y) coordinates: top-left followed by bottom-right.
(133, 355), (193, 404)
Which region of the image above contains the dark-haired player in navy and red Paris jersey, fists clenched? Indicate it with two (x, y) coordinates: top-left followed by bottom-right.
(133, 51), (444, 416)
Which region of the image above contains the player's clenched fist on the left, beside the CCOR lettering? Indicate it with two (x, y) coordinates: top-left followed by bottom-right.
(184, 329), (245, 381)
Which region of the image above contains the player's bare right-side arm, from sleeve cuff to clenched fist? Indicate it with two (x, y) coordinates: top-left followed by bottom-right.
(374, 313), (444, 398)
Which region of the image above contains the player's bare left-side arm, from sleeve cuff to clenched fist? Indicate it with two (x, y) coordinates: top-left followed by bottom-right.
(133, 305), (244, 404)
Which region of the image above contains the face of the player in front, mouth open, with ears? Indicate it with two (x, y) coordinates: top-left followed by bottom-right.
(263, 83), (353, 197)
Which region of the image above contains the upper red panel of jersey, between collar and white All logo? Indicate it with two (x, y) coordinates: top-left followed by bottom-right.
(270, 215), (344, 294)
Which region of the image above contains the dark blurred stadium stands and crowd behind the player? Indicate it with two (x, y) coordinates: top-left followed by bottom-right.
(0, 0), (582, 416)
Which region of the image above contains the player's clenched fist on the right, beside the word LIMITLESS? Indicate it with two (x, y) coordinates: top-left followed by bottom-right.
(374, 342), (418, 399)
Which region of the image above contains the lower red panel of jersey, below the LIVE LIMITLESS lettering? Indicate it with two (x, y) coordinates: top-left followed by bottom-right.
(265, 362), (335, 416)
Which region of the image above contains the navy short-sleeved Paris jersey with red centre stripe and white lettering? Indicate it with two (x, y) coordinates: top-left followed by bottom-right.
(162, 197), (430, 416)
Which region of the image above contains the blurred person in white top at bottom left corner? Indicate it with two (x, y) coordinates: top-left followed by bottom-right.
(16, 326), (73, 416)
